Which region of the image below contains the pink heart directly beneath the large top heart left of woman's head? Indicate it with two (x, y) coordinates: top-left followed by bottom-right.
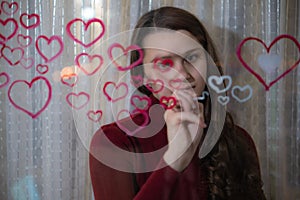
(75, 53), (103, 76)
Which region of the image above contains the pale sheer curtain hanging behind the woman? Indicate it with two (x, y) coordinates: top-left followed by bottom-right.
(0, 0), (300, 200)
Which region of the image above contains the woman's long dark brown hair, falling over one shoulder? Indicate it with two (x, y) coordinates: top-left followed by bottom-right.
(131, 7), (261, 199)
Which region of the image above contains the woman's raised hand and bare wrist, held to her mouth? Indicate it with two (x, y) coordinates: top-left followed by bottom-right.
(164, 90), (206, 172)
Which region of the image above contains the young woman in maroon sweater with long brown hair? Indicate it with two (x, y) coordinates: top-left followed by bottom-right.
(90, 7), (265, 200)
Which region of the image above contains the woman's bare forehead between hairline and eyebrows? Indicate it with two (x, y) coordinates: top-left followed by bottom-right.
(142, 30), (202, 55)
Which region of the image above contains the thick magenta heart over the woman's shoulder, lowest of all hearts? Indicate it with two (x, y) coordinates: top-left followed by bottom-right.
(116, 109), (149, 136)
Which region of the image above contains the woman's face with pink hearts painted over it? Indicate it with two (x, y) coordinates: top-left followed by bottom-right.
(143, 30), (207, 99)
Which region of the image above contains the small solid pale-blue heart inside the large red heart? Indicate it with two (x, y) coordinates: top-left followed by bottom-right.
(257, 53), (282, 74)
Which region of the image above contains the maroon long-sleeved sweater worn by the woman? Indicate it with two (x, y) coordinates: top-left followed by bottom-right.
(90, 96), (259, 200)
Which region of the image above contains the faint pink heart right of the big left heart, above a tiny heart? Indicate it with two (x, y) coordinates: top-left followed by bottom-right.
(66, 92), (90, 110)
